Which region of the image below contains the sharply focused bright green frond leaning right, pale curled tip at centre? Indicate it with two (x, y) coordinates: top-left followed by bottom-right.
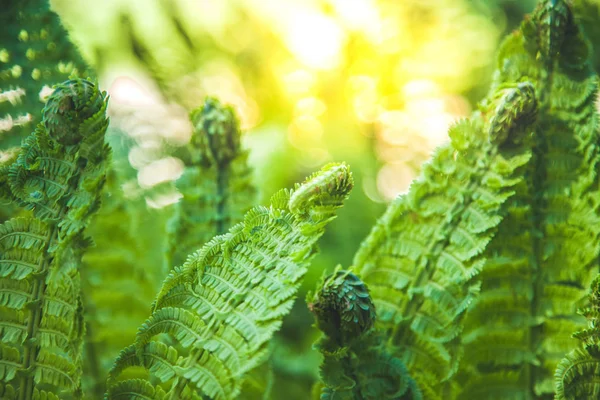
(107, 164), (353, 400)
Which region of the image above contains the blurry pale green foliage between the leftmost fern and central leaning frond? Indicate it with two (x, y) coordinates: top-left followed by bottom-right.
(81, 129), (168, 399)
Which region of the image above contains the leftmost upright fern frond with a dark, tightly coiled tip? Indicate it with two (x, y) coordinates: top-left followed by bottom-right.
(0, 80), (109, 400)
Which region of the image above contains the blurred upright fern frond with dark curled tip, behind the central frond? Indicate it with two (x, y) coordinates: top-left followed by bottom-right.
(167, 98), (255, 266)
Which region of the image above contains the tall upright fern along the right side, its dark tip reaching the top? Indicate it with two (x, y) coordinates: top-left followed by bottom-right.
(462, 0), (600, 399)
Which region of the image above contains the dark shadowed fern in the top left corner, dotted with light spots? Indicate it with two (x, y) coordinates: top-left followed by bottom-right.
(0, 0), (88, 149)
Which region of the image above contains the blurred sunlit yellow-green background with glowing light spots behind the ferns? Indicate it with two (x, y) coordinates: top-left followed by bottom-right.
(51, 0), (535, 400)
